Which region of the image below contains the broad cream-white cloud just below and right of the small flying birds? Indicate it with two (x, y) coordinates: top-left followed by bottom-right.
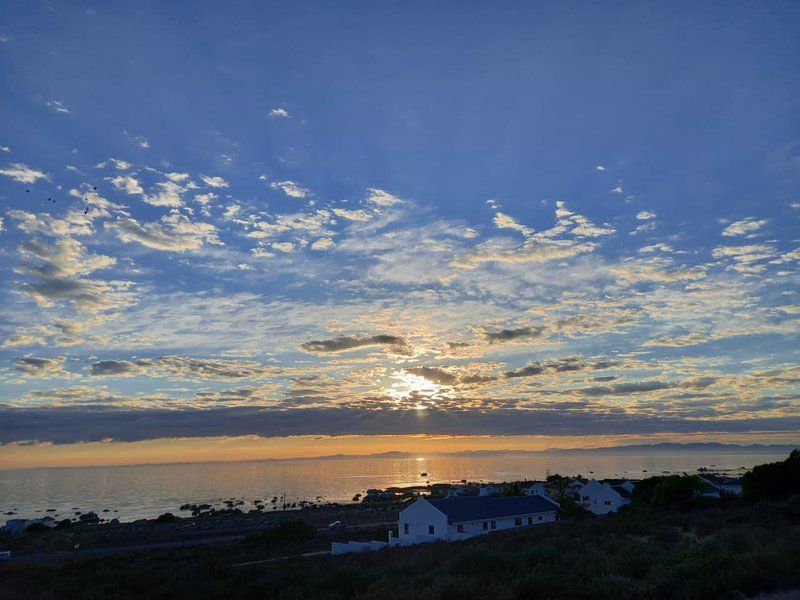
(105, 213), (222, 252)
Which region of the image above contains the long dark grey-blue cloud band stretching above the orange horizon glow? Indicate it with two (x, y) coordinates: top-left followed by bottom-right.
(0, 404), (800, 444)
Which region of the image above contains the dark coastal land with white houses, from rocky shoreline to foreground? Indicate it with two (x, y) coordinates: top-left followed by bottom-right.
(0, 450), (800, 600)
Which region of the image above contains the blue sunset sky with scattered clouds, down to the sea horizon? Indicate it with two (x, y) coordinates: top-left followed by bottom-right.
(0, 0), (800, 468)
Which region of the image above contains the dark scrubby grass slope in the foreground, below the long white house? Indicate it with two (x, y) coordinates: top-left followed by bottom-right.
(0, 499), (800, 600)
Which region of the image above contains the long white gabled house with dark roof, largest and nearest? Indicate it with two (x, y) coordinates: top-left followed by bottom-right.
(389, 495), (559, 546)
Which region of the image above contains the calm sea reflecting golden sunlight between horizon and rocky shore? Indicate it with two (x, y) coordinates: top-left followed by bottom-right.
(0, 453), (786, 522)
